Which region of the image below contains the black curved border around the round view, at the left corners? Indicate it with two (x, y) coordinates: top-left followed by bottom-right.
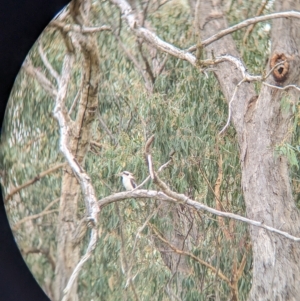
(0, 0), (69, 301)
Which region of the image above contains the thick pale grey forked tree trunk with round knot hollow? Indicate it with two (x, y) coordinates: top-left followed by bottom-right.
(196, 0), (300, 301)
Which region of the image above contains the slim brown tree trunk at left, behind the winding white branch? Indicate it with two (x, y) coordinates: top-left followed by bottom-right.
(54, 1), (100, 301)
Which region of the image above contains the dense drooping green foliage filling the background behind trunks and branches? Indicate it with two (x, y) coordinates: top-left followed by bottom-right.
(0, 1), (286, 300)
